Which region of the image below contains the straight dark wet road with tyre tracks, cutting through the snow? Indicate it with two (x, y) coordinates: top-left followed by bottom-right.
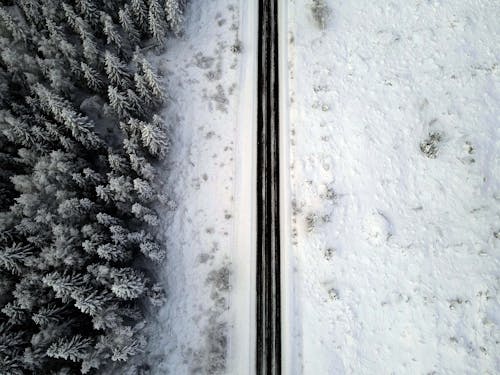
(256, 0), (281, 375)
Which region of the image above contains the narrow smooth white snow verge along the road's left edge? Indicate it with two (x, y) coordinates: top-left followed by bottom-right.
(227, 0), (258, 375)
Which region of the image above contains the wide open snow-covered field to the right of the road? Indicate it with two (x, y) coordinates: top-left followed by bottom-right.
(282, 0), (500, 375)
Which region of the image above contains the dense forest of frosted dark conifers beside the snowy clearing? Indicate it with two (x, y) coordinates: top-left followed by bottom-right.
(0, 0), (184, 374)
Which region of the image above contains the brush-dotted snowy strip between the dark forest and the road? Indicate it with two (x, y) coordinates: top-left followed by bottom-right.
(144, 0), (252, 375)
